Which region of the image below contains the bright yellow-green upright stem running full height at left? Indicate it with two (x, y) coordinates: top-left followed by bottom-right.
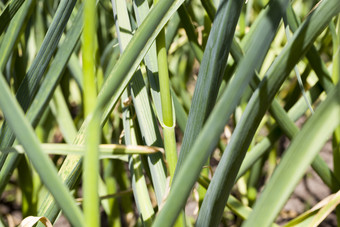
(82, 0), (101, 227)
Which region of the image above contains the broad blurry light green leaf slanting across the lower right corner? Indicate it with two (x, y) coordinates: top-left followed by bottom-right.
(244, 79), (340, 226)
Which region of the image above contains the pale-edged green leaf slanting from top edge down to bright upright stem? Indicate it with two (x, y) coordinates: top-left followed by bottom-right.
(98, 0), (184, 122)
